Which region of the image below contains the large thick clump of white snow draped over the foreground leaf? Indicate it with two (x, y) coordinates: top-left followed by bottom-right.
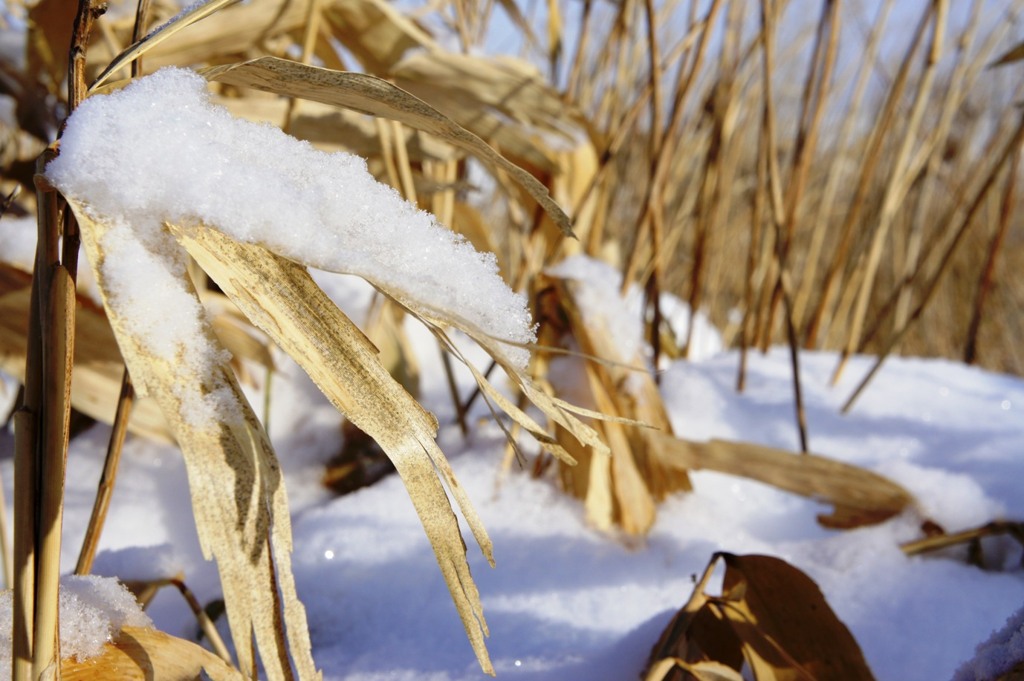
(46, 69), (535, 367)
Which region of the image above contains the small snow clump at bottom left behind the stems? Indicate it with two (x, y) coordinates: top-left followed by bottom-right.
(0, 574), (153, 670)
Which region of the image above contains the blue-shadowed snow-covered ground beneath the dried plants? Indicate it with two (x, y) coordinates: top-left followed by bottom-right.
(0, 268), (1024, 681)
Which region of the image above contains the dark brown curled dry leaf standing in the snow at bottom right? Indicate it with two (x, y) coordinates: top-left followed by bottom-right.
(645, 553), (874, 681)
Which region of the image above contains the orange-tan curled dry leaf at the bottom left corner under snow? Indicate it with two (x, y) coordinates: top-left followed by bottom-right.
(60, 627), (245, 681)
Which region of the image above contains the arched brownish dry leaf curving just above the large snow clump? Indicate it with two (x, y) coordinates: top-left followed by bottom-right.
(200, 56), (572, 236)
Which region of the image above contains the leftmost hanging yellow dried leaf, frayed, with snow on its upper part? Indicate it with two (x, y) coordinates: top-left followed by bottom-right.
(69, 204), (319, 681)
